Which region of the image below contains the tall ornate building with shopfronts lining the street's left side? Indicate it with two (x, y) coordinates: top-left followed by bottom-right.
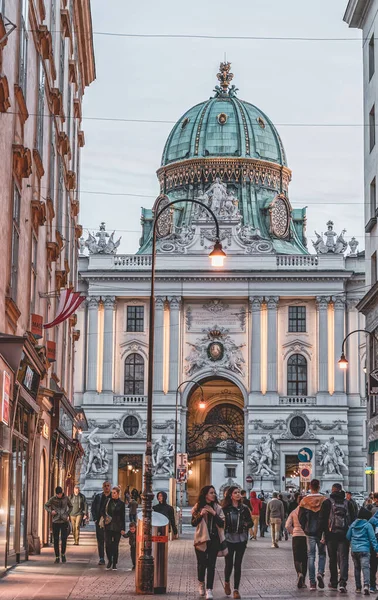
(0, 0), (95, 569)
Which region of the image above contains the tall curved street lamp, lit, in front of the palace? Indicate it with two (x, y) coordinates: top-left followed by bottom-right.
(136, 196), (226, 594)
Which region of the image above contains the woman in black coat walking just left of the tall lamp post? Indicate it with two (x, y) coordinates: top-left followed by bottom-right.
(101, 487), (126, 571)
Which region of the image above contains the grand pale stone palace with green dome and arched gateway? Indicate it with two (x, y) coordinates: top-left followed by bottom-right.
(75, 63), (366, 504)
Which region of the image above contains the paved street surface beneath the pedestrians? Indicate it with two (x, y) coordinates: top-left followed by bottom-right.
(0, 527), (375, 600)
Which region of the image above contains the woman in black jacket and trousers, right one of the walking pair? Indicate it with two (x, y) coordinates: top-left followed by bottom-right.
(222, 485), (252, 598)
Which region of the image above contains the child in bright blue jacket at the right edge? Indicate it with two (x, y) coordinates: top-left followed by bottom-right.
(347, 508), (378, 596)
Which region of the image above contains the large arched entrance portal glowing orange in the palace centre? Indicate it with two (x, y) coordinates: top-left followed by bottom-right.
(186, 377), (244, 506)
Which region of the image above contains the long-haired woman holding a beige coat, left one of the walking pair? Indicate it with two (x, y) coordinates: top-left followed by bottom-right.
(192, 485), (228, 600)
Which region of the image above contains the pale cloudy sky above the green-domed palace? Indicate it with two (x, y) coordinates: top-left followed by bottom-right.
(81, 0), (364, 253)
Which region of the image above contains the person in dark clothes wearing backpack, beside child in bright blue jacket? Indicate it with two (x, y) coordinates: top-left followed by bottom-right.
(319, 483), (354, 594)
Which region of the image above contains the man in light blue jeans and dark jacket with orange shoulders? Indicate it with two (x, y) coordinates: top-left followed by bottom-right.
(298, 479), (326, 592)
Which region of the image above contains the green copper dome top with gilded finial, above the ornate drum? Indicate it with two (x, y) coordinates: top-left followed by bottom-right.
(161, 63), (287, 166)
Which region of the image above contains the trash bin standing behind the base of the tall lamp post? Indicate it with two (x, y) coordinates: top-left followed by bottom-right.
(135, 511), (169, 594)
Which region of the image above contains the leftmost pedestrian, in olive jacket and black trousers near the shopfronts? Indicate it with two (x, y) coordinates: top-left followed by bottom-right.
(45, 485), (72, 563)
